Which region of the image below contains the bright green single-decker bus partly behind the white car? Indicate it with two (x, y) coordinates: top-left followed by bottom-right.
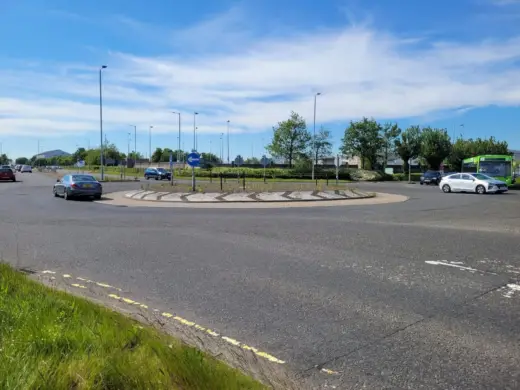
(462, 154), (515, 186)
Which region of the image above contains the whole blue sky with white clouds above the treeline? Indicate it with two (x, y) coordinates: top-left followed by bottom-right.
(0, 0), (520, 160)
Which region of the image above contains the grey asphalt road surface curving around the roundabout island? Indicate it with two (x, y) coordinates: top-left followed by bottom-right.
(0, 173), (520, 389)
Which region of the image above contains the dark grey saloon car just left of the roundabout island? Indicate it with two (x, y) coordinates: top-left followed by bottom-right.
(52, 175), (103, 200)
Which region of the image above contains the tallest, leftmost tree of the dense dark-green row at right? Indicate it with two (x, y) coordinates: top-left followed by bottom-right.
(341, 118), (383, 169)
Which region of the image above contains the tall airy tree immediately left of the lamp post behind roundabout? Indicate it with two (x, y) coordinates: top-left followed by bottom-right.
(266, 111), (312, 168)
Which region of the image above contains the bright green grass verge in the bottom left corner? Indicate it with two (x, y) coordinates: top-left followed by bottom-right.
(0, 264), (264, 390)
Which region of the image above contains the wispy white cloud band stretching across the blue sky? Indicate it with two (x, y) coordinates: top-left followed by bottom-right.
(0, 10), (520, 139)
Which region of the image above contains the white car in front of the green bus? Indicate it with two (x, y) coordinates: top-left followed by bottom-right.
(439, 173), (508, 195)
